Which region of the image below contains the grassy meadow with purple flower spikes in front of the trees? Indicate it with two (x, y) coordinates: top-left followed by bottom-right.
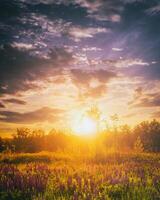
(0, 152), (160, 200)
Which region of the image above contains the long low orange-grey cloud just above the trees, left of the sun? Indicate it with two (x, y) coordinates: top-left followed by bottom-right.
(0, 107), (64, 124)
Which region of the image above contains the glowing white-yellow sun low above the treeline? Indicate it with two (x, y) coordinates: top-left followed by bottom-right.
(73, 116), (97, 136)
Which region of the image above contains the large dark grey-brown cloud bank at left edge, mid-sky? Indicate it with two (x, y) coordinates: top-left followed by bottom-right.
(0, 45), (72, 95)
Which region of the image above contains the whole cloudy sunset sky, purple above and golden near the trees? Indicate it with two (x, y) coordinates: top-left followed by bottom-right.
(0, 0), (160, 136)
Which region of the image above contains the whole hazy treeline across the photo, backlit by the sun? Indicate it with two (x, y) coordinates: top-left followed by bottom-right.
(0, 120), (160, 153)
